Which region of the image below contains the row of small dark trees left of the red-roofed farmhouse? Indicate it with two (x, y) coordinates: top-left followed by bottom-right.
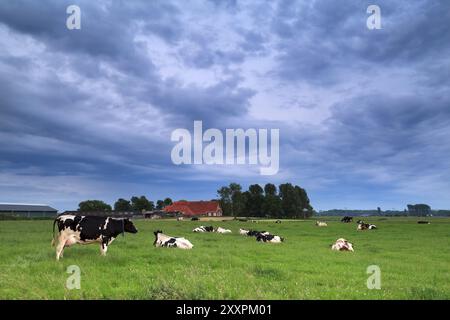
(78, 196), (172, 212)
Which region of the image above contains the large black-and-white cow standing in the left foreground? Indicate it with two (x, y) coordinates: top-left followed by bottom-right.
(52, 214), (137, 260)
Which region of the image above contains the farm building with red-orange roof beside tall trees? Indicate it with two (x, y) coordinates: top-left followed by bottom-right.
(164, 201), (222, 217)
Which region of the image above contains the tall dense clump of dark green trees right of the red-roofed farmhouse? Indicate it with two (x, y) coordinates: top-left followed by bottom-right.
(217, 183), (313, 218)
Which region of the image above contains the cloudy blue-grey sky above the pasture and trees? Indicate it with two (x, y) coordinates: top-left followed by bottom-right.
(0, 0), (450, 211)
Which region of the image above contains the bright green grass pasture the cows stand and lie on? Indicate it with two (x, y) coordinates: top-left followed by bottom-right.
(0, 218), (450, 299)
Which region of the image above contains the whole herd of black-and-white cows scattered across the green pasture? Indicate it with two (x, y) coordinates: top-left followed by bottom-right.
(52, 214), (390, 260)
